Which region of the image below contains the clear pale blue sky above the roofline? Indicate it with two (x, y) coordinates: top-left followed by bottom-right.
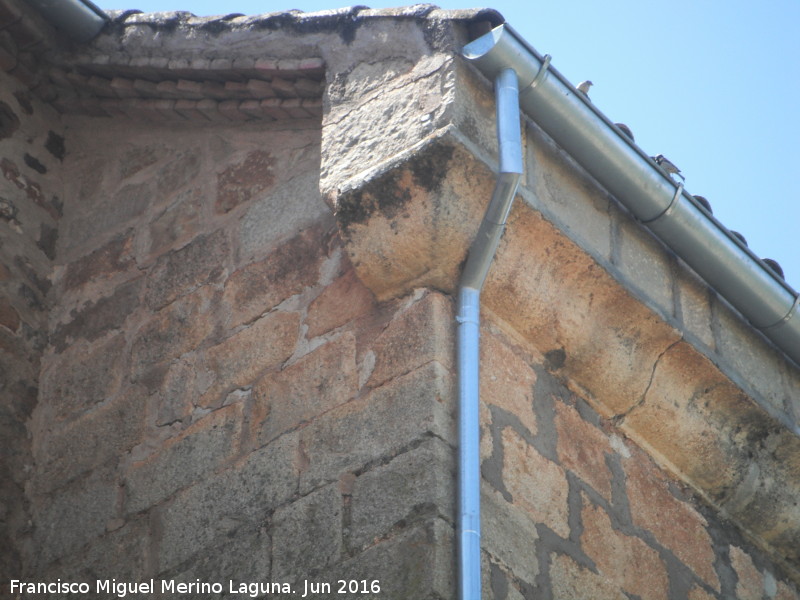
(100, 0), (800, 289)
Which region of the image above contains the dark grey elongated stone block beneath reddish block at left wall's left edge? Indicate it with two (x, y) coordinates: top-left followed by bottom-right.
(50, 277), (143, 352)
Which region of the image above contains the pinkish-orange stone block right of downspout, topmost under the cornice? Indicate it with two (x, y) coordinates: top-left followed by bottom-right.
(480, 329), (538, 435)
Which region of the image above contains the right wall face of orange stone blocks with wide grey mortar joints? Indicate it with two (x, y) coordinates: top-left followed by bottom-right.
(481, 324), (798, 600)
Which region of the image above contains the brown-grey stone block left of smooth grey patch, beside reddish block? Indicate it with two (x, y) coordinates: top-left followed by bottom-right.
(145, 229), (230, 310)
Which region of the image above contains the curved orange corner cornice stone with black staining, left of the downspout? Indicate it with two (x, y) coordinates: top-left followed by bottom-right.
(335, 134), (493, 300)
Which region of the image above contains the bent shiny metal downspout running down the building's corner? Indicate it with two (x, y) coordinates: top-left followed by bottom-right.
(456, 69), (522, 600)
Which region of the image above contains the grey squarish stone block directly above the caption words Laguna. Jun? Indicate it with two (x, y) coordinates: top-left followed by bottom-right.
(271, 484), (343, 582)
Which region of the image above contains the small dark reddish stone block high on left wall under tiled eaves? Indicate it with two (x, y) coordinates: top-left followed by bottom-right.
(214, 150), (276, 213)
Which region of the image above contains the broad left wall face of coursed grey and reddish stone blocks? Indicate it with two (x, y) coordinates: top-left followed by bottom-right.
(26, 111), (453, 598)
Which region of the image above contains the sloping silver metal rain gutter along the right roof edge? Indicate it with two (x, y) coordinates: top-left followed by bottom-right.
(463, 25), (800, 365)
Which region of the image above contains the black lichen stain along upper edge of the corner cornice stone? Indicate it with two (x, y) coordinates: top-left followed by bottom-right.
(336, 144), (454, 234)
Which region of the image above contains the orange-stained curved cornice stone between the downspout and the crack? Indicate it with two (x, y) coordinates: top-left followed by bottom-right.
(483, 205), (680, 415)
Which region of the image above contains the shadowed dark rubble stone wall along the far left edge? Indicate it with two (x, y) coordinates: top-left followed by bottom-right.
(0, 63), (64, 582)
